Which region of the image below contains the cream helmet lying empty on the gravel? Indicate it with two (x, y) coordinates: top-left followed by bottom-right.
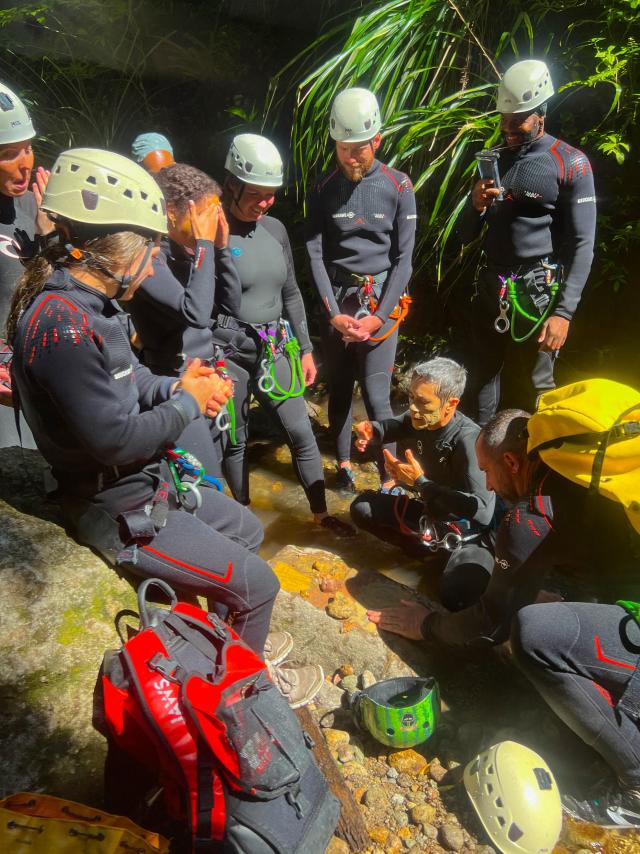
(464, 741), (562, 854)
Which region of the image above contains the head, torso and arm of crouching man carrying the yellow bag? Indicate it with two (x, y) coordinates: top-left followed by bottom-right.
(369, 409), (640, 647)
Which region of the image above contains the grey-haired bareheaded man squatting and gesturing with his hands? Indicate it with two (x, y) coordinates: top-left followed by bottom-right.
(351, 358), (495, 611)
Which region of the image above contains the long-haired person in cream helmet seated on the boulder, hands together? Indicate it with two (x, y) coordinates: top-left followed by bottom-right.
(8, 148), (330, 705)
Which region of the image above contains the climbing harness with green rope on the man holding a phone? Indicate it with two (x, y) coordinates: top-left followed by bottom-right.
(493, 261), (562, 344)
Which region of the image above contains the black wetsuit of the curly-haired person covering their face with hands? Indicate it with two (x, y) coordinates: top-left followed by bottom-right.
(126, 238), (245, 477)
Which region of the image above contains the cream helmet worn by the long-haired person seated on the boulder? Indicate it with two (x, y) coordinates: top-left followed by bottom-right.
(42, 148), (167, 234)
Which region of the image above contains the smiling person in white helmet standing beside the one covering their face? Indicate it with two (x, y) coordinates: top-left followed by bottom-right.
(214, 133), (354, 548)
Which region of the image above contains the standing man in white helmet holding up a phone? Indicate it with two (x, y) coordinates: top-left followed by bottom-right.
(458, 59), (596, 425)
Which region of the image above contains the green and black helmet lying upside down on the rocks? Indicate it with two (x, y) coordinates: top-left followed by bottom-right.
(351, 676), (440, 748)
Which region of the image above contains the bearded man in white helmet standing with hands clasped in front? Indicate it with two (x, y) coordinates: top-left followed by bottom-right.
(306, 88), (416, 492)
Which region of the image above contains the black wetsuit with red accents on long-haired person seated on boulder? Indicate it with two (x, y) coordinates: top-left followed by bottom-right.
(12, 269), (279, 653)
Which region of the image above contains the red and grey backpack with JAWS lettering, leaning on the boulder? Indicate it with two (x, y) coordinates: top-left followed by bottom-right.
(94, 579), (339, 854)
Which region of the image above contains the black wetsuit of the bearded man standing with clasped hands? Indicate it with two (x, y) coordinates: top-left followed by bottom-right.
(306, 160), (416, 480)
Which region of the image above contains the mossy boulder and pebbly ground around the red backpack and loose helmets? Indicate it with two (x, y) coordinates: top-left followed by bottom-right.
(0, 445), (640, 854)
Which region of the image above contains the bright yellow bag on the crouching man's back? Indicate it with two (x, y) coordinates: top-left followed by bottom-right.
(527, 379), (640, 533)
